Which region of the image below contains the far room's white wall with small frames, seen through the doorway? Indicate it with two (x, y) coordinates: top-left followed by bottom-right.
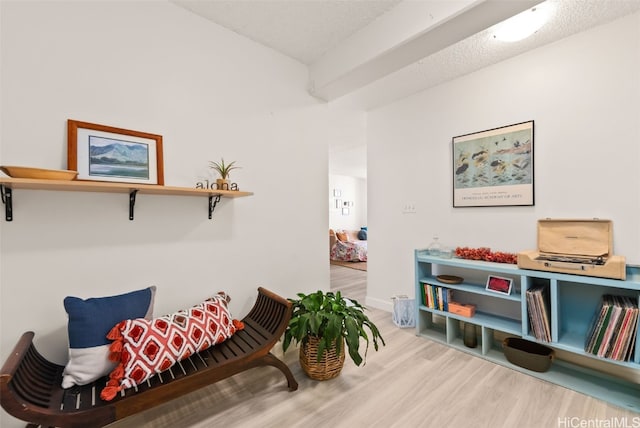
(329, 174), (367, 230)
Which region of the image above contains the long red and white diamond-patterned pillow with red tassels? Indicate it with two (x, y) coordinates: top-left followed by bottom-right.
(100, 293), (244, 401)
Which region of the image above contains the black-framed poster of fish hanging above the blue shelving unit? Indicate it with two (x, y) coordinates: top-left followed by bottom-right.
(452, 120), (535, 208)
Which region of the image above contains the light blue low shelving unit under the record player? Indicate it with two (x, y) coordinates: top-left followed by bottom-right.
(415, 250), (640, 413)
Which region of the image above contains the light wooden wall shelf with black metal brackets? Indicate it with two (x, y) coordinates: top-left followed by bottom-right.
(0, 177), (253, 221)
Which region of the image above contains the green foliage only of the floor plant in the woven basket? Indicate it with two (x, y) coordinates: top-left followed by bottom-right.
(282, 290), (385, 366)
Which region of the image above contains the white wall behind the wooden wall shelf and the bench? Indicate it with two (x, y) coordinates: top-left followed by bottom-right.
(0, 1), (329, 427)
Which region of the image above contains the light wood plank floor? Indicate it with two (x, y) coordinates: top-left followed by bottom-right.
(111, 266), (640, 428)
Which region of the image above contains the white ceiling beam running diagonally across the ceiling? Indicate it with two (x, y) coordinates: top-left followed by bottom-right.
(309, 0), (541, 101)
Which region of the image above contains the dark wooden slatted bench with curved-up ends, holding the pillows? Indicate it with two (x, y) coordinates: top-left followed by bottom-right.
(0, 288), (298, 428)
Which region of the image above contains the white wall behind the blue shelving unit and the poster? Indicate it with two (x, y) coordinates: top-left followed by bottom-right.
(367, 14), (640, 309)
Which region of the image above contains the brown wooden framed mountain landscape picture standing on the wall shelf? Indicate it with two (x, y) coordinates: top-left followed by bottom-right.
(67, 119), (164, 185)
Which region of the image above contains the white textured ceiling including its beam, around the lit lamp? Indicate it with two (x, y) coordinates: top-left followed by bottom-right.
(171, 0), (640, 110)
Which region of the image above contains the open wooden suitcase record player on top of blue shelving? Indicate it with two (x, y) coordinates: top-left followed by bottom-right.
(518, 219), (626, 279)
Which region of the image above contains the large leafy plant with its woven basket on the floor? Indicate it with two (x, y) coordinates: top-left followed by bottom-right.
(282, 290), (385, 380)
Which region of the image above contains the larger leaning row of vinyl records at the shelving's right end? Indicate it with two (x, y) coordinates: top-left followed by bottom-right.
(584, 294), (638, 361)
